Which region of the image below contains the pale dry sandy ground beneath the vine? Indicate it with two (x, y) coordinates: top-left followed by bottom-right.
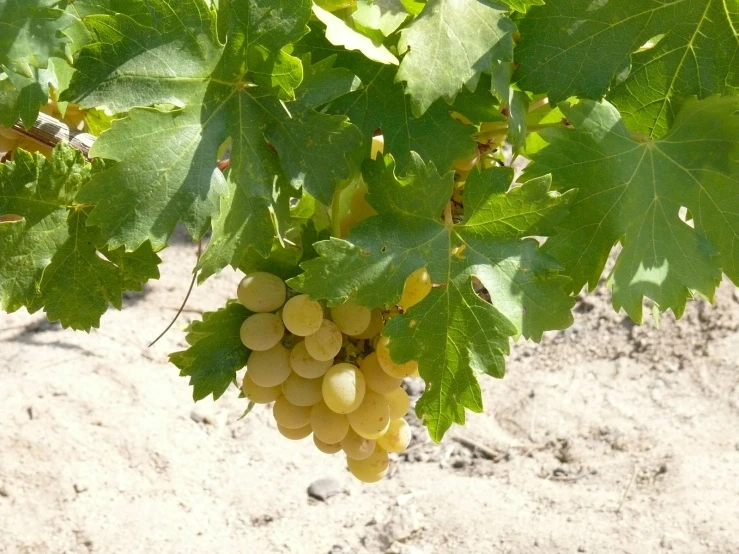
(0, 233), (739, 554)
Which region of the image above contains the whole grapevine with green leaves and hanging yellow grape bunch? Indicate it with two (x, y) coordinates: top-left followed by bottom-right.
(0, 0), (739, 482)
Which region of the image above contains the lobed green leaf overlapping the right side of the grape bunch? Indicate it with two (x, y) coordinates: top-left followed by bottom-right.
(290, 154), (573, 440)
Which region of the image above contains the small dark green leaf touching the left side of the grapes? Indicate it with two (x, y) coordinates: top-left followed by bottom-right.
(169, 302), (251, 401)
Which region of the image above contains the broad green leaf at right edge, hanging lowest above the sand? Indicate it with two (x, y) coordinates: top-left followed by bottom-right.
(525, 97), (739, 322)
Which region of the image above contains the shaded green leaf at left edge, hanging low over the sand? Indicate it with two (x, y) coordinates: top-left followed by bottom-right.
(0, 143), (160, 331)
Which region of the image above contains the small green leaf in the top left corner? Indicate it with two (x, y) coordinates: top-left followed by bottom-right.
(0, 0), (72, 79)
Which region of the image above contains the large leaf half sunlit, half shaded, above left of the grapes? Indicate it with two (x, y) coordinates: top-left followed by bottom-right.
(64, 0), (362, 279)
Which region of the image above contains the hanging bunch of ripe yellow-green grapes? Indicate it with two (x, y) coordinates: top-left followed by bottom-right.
(237, 268), (432, 483)
